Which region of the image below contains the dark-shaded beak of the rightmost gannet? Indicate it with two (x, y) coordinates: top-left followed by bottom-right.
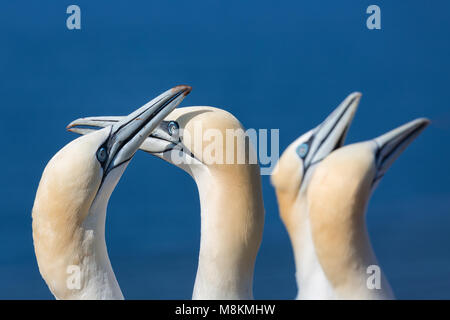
(373, 118), (430, 185)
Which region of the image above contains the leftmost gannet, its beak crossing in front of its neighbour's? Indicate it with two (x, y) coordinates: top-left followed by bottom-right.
(32, 86), (191, 299)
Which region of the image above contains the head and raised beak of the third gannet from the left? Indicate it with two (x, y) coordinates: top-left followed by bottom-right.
(271, 92), (361, 230)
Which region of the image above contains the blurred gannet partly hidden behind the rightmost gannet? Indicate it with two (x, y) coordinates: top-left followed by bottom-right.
(271, 92), (361, 299)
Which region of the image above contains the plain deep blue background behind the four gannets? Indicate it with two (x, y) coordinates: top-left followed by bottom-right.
(0, 0), (450, 299)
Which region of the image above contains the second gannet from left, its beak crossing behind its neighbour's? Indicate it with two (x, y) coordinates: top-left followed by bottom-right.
(69, 107), (264, 299)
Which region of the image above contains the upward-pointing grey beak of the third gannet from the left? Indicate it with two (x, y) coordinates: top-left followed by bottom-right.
(297, 92), (361, 172)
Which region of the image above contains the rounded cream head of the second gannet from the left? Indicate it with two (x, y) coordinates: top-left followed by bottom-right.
(142, 106), (257, 175)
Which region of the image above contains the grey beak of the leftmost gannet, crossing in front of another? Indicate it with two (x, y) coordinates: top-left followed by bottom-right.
(67, 86), (191, 173)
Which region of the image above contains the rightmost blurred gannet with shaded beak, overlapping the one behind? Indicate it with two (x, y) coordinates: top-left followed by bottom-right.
(307, 119), (429, 299)
